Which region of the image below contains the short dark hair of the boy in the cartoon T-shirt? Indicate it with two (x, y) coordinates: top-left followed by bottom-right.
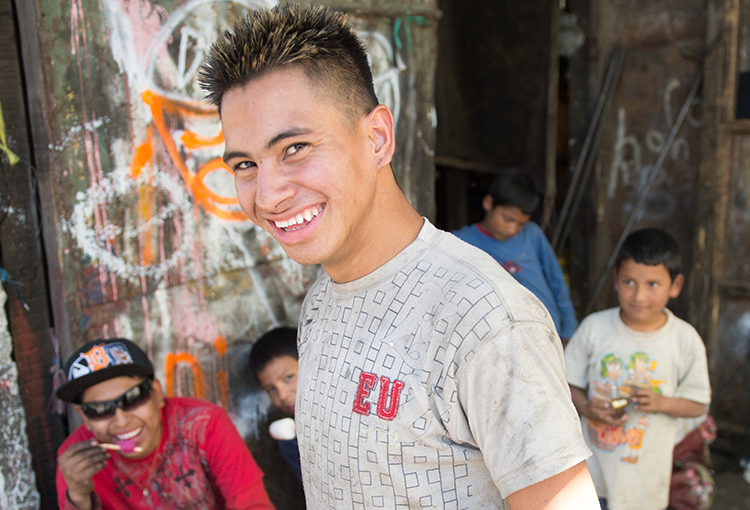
(615, 228), (682, 280)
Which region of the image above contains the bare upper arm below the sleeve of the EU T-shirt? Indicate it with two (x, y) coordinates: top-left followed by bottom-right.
(508, 462), (600, 510)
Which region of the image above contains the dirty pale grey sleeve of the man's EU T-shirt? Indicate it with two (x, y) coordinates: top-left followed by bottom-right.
(458, 321), (590, 498)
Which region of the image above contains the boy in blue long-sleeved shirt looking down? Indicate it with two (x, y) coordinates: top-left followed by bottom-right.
(454, 168), (578, 345)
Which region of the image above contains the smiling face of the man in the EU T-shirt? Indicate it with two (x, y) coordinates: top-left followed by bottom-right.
(221, 66), (382, 274)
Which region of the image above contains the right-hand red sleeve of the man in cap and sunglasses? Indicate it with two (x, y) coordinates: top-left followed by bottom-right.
(204, 408), (274, 510)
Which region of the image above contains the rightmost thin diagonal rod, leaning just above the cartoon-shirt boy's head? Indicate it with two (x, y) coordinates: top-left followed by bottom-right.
(586, 70), (703, 315)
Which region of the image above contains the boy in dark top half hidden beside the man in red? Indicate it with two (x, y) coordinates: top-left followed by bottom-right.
(247, 327), (302, 481)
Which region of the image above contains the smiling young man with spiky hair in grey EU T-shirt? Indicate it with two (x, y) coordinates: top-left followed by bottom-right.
(202, 4), (597, 510)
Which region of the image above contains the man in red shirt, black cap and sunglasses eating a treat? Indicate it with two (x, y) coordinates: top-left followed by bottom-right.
(57, 339), (273, 510)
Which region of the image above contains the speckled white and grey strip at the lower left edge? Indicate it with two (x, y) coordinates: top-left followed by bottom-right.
(0, 287), (40, 510)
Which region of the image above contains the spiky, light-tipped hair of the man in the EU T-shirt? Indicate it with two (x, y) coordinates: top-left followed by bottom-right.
(198, 3), (378, 118)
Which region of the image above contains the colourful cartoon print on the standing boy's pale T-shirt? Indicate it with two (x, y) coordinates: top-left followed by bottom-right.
(588, 351), (664, 464)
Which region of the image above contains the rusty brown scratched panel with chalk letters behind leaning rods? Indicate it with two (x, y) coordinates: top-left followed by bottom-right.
(570, 0), (706, 318)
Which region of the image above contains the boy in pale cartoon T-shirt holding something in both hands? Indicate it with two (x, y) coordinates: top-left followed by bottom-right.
(565, 229), (711, 510)
